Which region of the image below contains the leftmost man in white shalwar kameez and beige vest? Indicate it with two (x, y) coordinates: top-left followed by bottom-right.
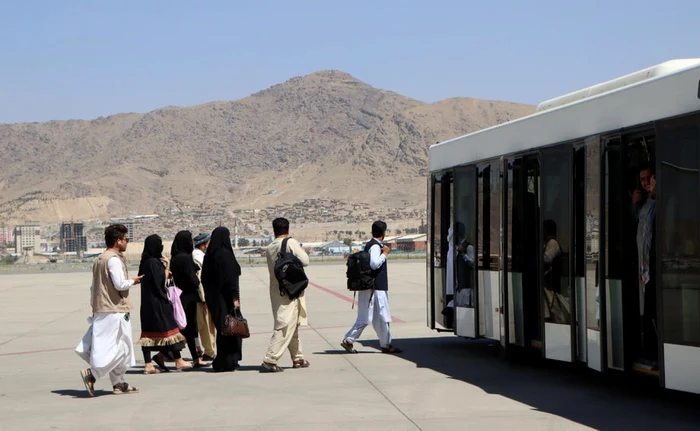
(75, 224), (141, 396)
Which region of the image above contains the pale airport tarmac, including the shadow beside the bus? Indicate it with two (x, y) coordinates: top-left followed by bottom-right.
(0, 260), (700, 431)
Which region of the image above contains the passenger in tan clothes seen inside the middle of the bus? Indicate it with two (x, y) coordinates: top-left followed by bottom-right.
(542, 220), (571, 324)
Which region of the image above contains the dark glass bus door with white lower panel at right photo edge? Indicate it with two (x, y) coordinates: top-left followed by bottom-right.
(647, 114), (700, 394)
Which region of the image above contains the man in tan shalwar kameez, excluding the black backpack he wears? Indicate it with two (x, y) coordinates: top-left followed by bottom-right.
(260, 218), (309, 373)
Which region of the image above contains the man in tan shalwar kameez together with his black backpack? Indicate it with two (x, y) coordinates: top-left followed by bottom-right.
(260, 217), (309, 373)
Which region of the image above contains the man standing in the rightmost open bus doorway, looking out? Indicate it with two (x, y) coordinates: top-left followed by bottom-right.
(632, 162), (658, 367)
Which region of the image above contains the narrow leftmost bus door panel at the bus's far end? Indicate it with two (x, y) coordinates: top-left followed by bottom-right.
(428, 174), (453, 329)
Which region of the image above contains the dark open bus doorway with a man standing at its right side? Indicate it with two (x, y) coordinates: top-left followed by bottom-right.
(602, 129), (658, 376)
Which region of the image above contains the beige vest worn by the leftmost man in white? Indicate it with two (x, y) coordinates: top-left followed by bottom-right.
(92, 250), (131, 313)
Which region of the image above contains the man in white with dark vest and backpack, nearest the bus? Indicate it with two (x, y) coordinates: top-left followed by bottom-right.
(340, 220), (401, 353)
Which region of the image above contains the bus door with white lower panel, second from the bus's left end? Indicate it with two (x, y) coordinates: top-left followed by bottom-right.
(452, 166), (480, 338)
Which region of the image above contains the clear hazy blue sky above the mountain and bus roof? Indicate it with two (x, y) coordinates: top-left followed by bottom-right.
(0, 0), (700, 123)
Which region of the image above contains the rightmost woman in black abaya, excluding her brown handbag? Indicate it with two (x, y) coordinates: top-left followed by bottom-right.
(202, 226), (243, 371)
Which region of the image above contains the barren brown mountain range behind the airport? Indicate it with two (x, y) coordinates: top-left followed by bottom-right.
(0, 71), (534, 222)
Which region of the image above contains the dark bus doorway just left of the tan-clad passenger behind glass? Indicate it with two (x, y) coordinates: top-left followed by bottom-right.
(502, 155), (542, 348)
